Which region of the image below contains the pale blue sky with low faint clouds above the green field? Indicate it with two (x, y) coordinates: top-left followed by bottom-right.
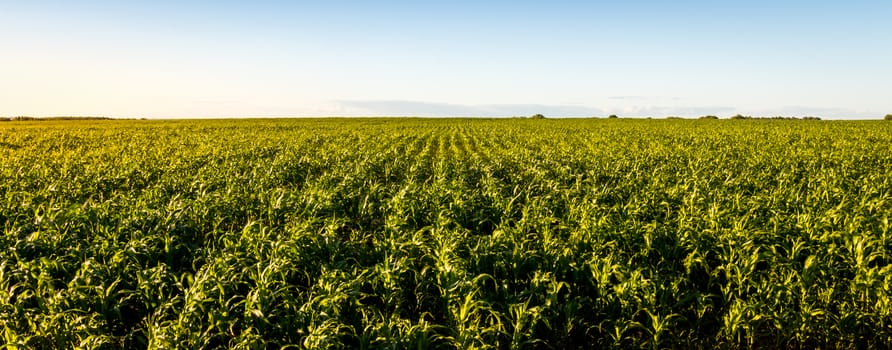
(0, 0), (892, 119)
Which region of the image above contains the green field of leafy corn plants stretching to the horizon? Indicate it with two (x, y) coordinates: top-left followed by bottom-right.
(0, 119), (892, 349)
